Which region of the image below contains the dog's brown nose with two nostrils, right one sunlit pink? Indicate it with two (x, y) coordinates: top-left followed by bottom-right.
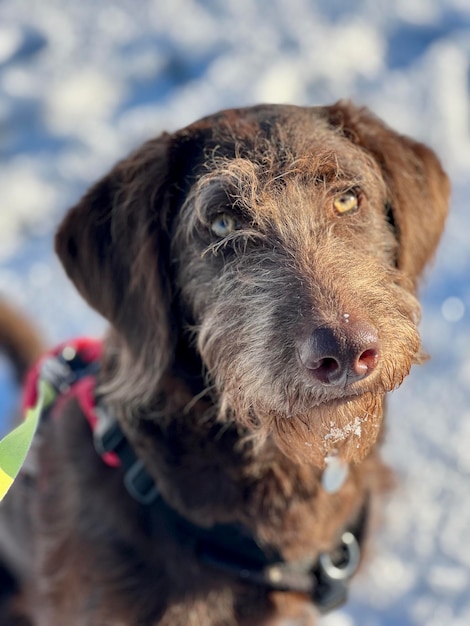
(299, 320), (379, 386)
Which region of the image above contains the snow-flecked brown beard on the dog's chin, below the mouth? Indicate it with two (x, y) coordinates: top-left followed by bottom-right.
(202, 336), (419, 468)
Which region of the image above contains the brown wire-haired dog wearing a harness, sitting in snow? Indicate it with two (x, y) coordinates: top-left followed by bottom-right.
(0, 101), (449, 626)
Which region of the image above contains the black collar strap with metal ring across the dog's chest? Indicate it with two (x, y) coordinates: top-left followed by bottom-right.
(42, 350), (369, 613)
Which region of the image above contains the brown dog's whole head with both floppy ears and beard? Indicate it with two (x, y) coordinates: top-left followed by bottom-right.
(57, 104), (448, 466)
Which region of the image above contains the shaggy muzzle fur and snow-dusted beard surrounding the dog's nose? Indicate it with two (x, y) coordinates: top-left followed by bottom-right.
(197, 246), (422, 467)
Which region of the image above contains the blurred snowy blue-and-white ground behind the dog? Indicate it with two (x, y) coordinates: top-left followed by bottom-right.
(0, 0), (470, 626)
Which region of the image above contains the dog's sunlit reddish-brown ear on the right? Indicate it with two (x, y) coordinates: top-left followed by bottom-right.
(327, 101), (450, 285)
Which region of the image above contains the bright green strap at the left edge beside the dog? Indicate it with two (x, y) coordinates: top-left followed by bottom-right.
(0, 378), (57, 501)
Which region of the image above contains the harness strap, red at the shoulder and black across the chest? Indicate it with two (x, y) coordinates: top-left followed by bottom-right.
(24, 339), (368, 613)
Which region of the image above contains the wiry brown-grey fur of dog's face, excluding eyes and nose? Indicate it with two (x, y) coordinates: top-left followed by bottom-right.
(174, 114), (426, 467)
